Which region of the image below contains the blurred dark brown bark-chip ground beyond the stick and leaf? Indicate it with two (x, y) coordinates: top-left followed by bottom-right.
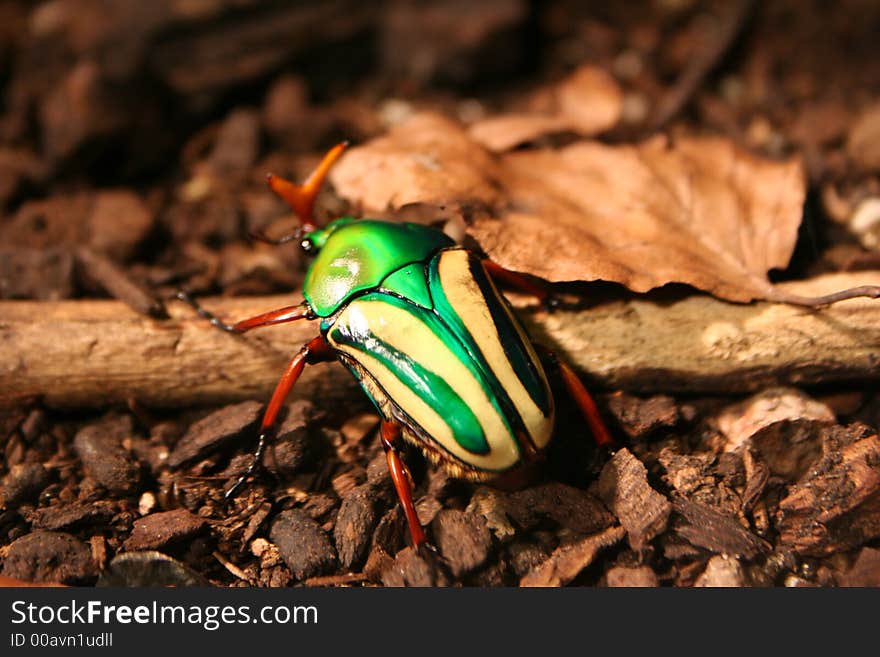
(0, 0), (880, 298)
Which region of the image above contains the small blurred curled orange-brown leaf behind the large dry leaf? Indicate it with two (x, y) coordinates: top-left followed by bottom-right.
(469, 65), (623, 152)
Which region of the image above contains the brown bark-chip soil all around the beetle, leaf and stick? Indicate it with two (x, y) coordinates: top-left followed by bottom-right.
(0, 0), (880, 587)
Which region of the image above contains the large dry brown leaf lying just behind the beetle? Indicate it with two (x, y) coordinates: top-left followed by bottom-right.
(331, 114), (820, 303)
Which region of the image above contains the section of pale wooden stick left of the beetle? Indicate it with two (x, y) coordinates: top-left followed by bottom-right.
(0, 296), (352, 407)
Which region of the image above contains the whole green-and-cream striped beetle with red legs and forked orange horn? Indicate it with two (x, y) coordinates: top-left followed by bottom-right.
(178, 143), (613, 546)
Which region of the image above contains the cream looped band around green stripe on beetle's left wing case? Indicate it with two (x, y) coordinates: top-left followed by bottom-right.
(328, 299), (520, 470)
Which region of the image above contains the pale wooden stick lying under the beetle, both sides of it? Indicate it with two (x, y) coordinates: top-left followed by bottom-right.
(0, 272), (880, 407)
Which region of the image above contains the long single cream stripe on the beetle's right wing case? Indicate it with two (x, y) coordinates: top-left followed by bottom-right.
(437, 249), (553, 447)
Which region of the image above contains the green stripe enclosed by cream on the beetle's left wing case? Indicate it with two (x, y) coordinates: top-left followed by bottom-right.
(330, 296), (490, 455)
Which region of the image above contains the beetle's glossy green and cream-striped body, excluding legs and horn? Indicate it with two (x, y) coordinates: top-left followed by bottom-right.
(305, 220), (553, 478)
